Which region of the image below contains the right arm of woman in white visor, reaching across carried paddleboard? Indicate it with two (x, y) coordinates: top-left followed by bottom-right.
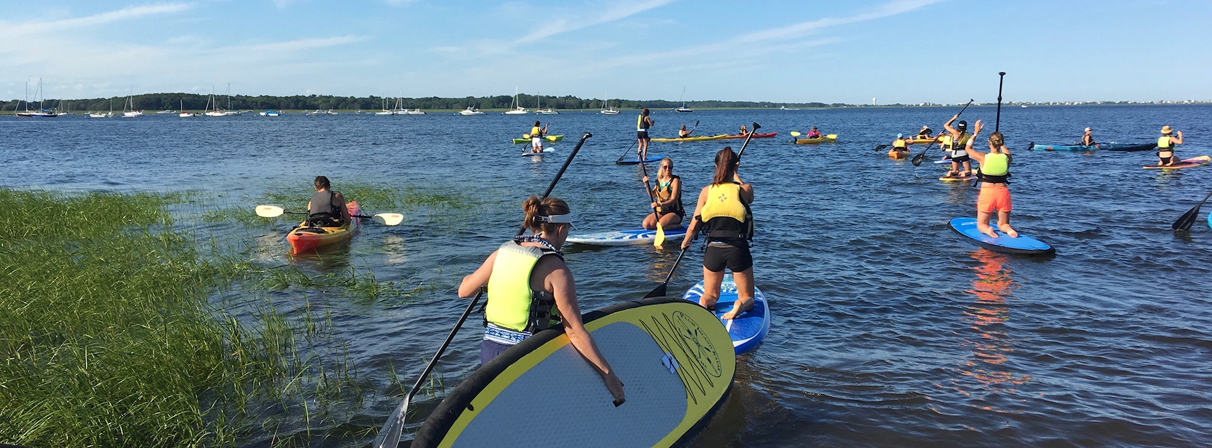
(547, 257), (627, 404)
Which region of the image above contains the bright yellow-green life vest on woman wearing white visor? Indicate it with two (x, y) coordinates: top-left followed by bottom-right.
(484, 241), (560, 332)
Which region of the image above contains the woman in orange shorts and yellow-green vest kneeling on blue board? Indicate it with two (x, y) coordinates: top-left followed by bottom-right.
(964, 120), (1018, 239)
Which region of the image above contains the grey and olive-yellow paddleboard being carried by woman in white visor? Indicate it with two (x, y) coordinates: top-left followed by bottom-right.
(412, 298), (737, 447)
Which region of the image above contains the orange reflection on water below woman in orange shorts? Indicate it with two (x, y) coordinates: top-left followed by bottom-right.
(956, 249), (1030, 412)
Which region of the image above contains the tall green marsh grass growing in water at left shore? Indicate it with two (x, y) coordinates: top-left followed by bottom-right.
(0, 189), (360, 447)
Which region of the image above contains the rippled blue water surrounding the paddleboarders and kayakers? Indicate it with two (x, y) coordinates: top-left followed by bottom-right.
(0, 107), (1212, 447)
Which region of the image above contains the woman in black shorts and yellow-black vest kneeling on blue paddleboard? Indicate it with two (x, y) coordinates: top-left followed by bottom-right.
(681, 147), (754, 320)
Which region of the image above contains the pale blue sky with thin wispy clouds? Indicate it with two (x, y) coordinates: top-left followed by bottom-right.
(0, 0), (1212, 104)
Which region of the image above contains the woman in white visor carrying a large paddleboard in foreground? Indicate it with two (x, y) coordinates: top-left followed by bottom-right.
(458, 196), (624, 403)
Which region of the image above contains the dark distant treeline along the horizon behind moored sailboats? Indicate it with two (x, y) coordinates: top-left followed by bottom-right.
(0, 93), (850, 111)
